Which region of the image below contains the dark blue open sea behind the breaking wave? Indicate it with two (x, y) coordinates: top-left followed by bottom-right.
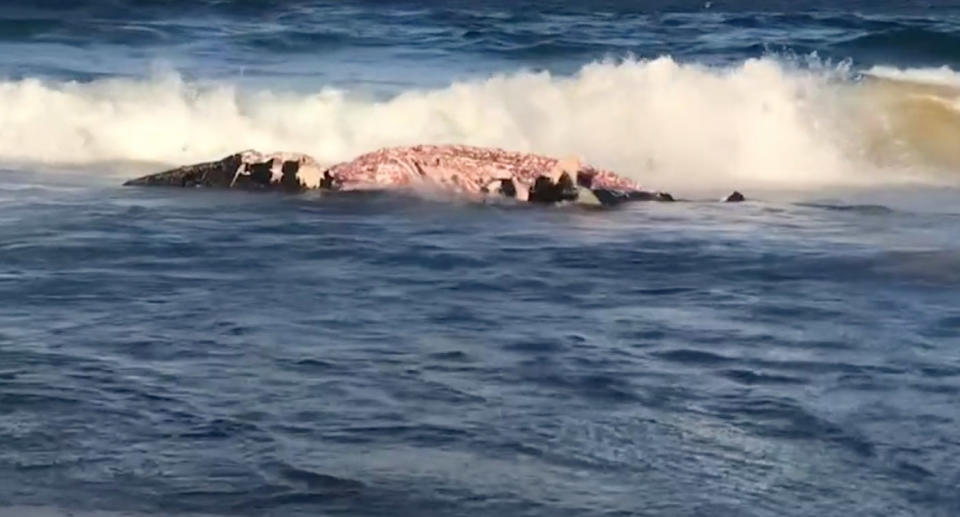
(0, 0), (960, 85)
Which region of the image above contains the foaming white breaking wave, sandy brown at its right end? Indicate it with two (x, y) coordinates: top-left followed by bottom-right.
(0, 57), (960, 188)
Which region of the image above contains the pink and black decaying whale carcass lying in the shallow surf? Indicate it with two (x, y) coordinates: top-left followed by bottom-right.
(124, 145), (728, 205)
